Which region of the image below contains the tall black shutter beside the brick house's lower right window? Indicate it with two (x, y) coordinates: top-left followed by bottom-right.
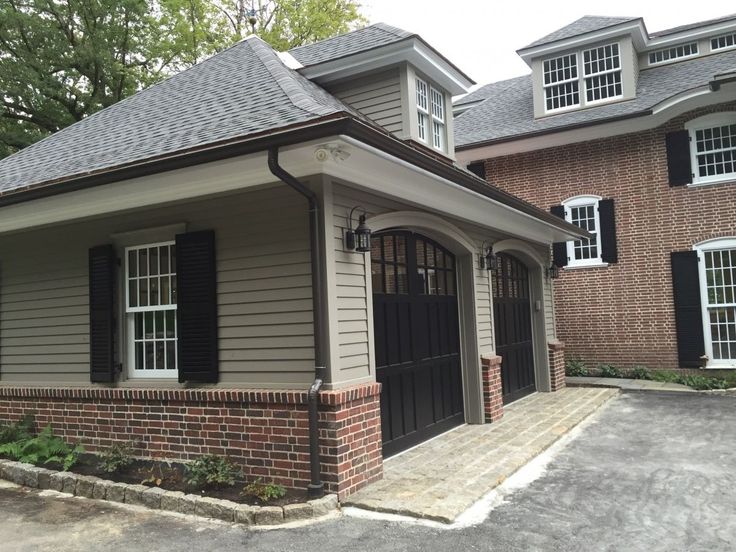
(671, 251), (705, 368)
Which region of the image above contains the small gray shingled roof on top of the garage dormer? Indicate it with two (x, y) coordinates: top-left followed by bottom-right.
(289, 23), (417, 67)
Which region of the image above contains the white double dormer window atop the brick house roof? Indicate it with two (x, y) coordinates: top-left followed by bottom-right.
(543, 42), (623, 113)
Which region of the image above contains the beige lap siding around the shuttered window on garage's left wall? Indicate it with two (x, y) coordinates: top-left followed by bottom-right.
(0, 186), (314, 387)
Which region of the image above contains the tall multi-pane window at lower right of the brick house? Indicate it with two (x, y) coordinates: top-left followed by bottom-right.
(703, 247), (736, 364)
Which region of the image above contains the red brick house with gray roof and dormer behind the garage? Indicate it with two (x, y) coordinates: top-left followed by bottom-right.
(455, 16), (736, 369)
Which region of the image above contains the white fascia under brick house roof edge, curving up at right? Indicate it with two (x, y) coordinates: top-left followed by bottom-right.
(455, 83), (736, 166)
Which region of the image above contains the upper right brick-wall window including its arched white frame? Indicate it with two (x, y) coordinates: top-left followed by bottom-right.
(685, 112), (736, 184)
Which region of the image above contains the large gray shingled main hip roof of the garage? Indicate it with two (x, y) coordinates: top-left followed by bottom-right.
(0, 38), (354, 194)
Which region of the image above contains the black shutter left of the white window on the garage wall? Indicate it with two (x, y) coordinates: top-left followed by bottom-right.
(89, 245), (117, 383)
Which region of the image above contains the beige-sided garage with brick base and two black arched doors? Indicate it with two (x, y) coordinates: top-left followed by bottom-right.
(0, 24), (588, 497)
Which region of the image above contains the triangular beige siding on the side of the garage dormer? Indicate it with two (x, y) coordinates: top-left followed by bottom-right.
(330, 68), (404, 134)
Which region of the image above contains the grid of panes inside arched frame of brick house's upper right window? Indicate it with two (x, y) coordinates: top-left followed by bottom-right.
(694, 123), (736, 180)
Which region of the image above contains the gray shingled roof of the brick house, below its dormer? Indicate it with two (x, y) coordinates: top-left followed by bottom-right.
(455, 50), (736, 148)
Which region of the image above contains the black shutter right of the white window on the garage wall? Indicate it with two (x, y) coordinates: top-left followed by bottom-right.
(176, 230), (219, 383)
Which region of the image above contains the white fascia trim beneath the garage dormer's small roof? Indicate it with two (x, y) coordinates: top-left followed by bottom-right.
(300, 38), (474, 95)
